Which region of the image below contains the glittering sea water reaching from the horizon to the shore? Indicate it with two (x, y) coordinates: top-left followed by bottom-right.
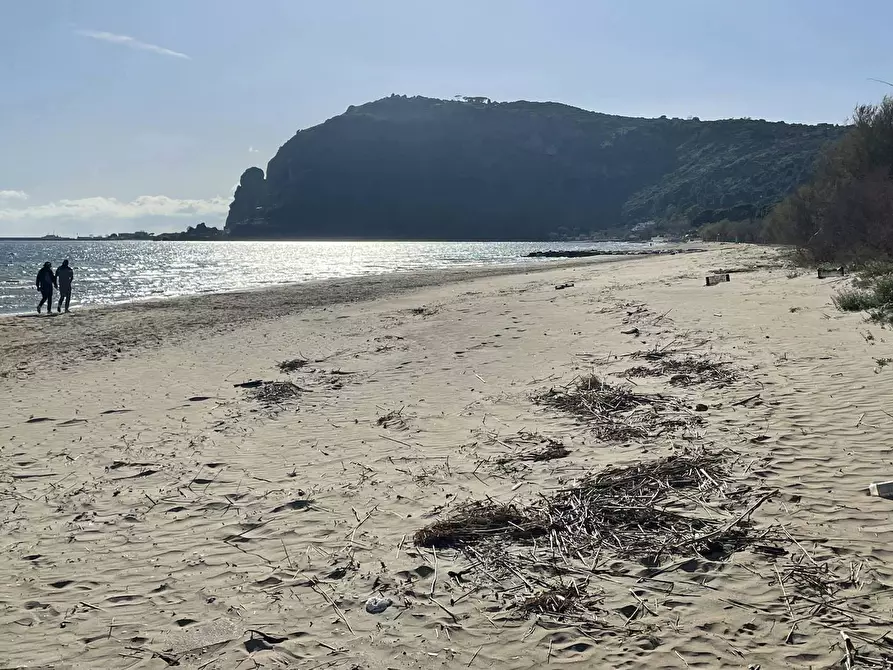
(0, 241), (656, 314)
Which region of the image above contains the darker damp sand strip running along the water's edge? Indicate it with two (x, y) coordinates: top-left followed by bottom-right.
(0, 251), (700, 376)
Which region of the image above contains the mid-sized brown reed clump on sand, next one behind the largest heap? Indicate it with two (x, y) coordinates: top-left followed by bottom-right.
(534, 375), (703, 441)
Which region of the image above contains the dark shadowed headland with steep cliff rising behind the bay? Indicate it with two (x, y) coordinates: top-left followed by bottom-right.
(226, 96), (845, 240)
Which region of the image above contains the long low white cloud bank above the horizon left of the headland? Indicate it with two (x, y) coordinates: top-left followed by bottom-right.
(0, 195), (230, 222)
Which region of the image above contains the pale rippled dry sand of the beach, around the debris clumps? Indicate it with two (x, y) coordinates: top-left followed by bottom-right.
(0, 246), (893, 670)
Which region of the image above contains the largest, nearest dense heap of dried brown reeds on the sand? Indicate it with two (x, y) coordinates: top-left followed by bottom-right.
(414, 451), (765, 572)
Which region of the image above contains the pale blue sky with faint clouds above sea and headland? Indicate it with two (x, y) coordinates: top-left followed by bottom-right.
(0, 0), (893, 236)
